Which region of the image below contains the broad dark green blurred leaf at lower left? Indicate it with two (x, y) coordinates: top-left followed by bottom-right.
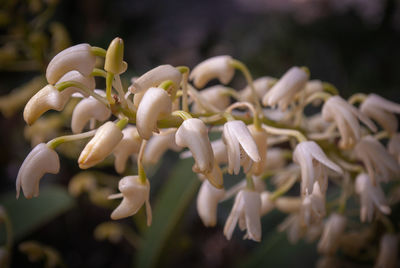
(0, 185), (75, 245)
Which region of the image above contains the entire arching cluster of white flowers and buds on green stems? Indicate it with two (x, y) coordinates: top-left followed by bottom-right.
(16, 38), (400, 267)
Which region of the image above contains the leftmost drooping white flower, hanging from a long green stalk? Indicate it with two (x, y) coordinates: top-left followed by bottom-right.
(16, 143), (60, 199)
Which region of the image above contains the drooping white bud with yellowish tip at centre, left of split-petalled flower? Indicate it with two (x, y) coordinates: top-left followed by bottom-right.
(175, 118), (214, 174)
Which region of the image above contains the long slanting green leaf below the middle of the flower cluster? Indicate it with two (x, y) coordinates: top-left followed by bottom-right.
(135, 159), (200, 267)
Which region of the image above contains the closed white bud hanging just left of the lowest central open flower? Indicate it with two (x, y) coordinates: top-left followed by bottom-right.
(196, 180), (225, 227)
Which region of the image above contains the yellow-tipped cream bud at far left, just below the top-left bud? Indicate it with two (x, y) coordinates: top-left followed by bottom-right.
(24, 85), (69, 125)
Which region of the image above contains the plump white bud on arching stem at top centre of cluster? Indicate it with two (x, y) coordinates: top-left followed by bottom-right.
(190, 56), (235, 88)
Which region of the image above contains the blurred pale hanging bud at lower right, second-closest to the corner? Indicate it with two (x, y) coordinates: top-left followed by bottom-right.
(318, 213), (347, 255)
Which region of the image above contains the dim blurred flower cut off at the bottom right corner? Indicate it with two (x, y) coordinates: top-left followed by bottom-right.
(375, 233), (399, 268)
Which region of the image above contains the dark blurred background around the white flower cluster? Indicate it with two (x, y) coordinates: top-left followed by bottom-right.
(0, 0), (400, 267)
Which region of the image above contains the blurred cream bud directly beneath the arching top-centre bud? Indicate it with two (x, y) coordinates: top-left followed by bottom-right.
(191, 85), (231, 113)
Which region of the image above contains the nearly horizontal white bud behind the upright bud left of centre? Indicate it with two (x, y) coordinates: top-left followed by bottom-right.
(129, 64), (182, 94)
